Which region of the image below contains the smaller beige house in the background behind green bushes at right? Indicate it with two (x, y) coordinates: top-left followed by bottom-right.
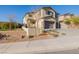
(58, 13), (75, 29)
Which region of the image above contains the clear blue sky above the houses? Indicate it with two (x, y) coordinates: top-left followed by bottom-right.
(0, 5), (79, 23)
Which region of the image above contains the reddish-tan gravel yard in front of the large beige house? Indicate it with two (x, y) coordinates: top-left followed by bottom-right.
(0, 29), (59, 43)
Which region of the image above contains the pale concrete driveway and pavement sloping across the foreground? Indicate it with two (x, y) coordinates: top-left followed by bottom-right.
(0, 29), (79, 53)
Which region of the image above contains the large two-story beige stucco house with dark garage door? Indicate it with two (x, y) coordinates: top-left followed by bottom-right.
(23, 7), (59, 35)
